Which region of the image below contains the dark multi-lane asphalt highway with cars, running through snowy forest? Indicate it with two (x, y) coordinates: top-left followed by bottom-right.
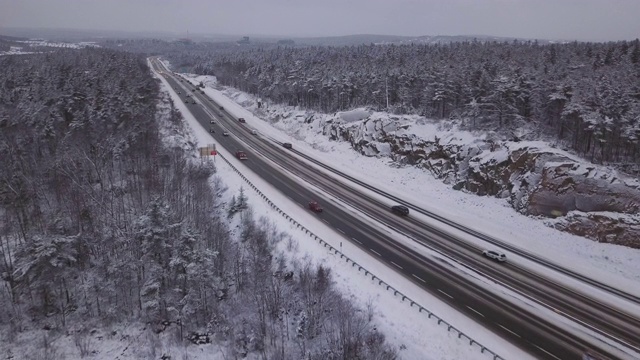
(154, 62), (640, 360)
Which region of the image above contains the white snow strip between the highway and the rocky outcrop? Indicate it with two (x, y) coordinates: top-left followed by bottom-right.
(185, 76), (640, 295)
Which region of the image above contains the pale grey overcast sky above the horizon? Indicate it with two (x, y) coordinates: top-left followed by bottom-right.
(0, 0), (640, 41)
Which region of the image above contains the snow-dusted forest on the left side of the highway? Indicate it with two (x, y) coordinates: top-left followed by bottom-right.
(0, 49), (397, 359)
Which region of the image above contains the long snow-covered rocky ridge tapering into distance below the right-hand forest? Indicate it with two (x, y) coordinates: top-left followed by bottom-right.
(211, 82), (640, 248)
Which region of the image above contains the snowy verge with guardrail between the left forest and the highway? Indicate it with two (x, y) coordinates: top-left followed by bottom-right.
(168, 71), (531, 360)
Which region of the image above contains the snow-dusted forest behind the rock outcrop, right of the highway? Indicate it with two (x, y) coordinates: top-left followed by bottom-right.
(170, 40), (640, 163)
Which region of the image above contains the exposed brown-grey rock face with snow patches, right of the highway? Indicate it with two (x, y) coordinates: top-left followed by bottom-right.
(323, 118), (640, 248)
